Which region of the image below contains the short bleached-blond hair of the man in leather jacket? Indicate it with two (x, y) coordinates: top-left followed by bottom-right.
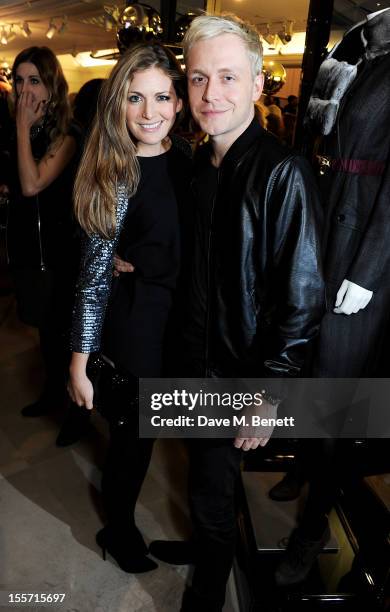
(183, 14), (263, 78)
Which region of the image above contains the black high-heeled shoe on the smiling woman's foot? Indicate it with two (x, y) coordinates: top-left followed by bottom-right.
(96, 527), (158, 574)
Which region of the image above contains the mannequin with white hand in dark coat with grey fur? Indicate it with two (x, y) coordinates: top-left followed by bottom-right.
(306, 8), (390, 377)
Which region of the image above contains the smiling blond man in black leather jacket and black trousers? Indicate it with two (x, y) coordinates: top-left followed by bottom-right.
(150, 15), (324, 612)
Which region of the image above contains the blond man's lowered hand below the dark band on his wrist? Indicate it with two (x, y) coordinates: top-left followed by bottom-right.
(234, 399), (278, 451)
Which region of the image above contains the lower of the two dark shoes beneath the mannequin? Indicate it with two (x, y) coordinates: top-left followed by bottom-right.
(275, 526), (330, 587)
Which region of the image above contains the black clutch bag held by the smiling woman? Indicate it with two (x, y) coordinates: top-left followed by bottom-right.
(87, 353), (138, 426)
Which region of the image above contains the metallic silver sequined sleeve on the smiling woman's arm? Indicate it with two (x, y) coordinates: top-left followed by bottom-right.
(71, 186), (129, 353)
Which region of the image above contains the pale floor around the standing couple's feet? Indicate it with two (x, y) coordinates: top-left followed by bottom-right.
(0, 296), (237, 612)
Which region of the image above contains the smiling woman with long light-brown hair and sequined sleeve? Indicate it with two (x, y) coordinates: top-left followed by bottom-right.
(69, 43), (191, 572)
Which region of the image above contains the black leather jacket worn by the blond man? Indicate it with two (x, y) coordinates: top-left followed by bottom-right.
(193, 119), (325, 377)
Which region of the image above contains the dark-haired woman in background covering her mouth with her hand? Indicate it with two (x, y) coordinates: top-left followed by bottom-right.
(0, 47), (79, 416)
